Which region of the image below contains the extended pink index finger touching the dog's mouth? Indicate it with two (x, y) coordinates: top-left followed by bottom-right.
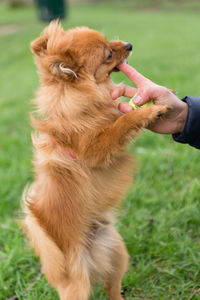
(117, 63), (152, 88)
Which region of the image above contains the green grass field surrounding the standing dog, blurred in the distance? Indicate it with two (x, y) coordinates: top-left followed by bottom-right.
(0, 1), (200, 300)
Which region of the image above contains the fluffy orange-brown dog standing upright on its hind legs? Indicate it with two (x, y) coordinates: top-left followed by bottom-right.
(23, 22), (167, 300)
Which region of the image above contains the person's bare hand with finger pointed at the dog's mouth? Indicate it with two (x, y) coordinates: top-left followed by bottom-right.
(111, 63), (188, 134)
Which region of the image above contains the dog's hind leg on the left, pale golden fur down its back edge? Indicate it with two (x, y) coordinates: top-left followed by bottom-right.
(22, 216), (90, 300)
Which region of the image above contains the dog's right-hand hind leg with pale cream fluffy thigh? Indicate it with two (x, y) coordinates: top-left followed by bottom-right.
(88, 224), (129, 300)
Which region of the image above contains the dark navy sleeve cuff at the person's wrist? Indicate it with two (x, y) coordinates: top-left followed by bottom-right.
(172, 96), (200, 149)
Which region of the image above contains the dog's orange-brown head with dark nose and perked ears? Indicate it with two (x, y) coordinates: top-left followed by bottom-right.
(31, 21), (132, 82)
